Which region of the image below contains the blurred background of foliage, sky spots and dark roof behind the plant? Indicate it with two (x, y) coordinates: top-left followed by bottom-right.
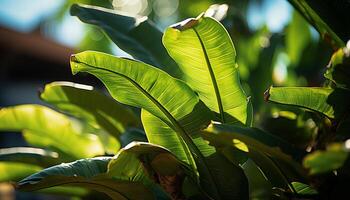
(0, 0), (332, 199)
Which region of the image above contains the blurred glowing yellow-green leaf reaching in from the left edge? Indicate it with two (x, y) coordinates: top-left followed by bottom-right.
(0, 105), (104, 158)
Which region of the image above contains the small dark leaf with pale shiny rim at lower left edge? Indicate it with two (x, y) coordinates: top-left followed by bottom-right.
(0, 147), (60, 167)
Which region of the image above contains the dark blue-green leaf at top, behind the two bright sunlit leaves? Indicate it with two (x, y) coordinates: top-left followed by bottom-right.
(70, 4), (180, 76)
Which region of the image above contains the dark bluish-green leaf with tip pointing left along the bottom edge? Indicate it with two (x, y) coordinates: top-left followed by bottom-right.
(18, 157), (152, 199)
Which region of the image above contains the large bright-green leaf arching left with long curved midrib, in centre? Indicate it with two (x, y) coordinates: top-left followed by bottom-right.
(71, 52), (247, 199)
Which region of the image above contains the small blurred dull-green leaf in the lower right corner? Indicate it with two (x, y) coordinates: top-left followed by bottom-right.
(303, 143), (349, 174)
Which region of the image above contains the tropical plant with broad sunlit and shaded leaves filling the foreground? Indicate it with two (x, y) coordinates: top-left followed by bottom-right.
(0, 1), (350, 199)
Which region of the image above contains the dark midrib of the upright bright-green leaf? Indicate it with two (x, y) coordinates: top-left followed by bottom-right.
(193, 27), (225, 123)
